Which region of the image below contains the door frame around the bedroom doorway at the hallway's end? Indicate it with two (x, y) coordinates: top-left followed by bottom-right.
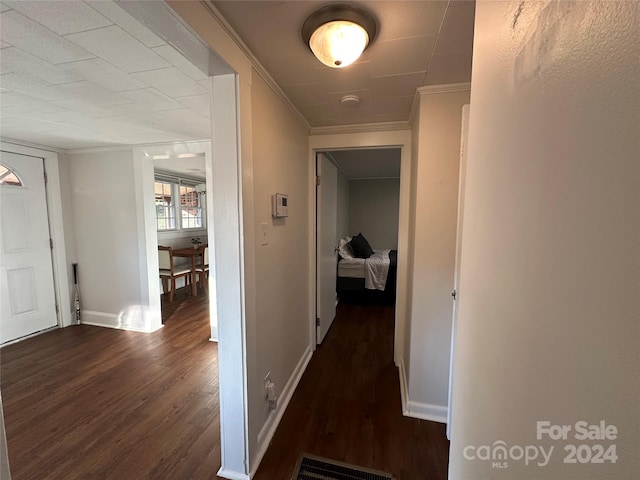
(308, 126), (411, 362)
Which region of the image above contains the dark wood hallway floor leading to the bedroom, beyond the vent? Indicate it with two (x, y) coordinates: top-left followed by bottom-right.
(256, 305), (449, 480)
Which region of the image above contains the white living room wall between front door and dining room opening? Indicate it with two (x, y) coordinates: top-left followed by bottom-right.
(69, 148), (147, 327)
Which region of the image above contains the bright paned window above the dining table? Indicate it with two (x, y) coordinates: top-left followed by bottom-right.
(155, 176), (206, 231)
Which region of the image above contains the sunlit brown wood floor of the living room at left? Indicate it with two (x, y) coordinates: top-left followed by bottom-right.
(0, 292), (220, 480)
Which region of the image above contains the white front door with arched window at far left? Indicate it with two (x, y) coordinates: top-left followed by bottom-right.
(0, 152), (58, 343)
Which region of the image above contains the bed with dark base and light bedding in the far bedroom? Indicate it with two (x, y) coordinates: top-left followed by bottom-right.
(336, 246), (398, 305)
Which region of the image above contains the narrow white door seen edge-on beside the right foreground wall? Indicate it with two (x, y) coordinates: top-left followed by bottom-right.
(447, 105), (469, 439)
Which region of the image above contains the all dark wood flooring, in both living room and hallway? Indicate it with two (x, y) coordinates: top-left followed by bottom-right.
(0, 294), (449, 480)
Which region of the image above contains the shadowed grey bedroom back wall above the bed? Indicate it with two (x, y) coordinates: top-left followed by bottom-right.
(349, 178), (400, 250)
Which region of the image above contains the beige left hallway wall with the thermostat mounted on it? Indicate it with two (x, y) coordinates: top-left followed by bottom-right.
(247, 68), (311, 462)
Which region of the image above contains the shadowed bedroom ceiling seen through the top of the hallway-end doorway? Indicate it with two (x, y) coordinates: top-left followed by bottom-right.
(325, 148), (401, 180)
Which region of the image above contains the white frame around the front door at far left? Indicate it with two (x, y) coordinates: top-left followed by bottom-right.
(0, 139), (73, 332)
